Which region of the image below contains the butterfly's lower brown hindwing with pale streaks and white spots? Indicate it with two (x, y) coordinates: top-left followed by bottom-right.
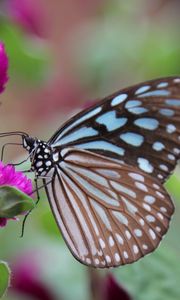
(43, 148), (174, 268)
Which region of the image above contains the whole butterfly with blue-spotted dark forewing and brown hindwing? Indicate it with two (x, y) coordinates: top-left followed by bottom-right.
(7, 77), (180, 268)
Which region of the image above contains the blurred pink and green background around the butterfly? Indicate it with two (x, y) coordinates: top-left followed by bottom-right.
(0, 0), (180, 300)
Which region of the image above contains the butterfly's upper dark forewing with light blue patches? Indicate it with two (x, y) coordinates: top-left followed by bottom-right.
(49, 77), (180, 182)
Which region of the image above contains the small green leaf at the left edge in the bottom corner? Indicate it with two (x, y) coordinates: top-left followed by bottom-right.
(0, 261), (11, 298)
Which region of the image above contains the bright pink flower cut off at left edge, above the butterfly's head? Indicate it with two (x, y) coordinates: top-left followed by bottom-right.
(0, 41), (8, 93)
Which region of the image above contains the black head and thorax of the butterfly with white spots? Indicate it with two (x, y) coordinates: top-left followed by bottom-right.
(23, 136), (60, 176)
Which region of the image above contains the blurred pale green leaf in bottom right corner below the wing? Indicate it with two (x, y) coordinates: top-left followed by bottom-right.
(114, 243), (180, 300)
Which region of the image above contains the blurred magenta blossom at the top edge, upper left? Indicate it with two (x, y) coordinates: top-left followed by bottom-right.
(7, 0), (45, 37)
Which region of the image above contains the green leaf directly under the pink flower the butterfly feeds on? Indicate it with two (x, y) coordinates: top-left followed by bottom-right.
(0, 186), (35, 218)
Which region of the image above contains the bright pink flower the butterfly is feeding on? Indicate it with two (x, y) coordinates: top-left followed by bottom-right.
(0, 161), (33, 227)
